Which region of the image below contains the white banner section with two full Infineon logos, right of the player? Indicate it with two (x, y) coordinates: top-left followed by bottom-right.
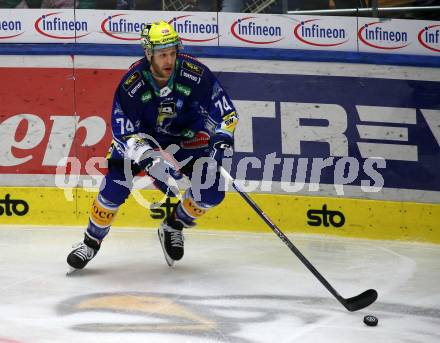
(218, 13), (357, 51)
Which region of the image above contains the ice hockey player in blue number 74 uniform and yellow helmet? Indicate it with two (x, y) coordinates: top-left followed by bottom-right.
(67, 21), (238, 270)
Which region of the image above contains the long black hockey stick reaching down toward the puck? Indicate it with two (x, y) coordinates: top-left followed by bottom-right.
(220, 167), (377, 312)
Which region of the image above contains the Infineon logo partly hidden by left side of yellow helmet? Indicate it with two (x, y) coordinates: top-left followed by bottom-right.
(101, 14), (146, 40)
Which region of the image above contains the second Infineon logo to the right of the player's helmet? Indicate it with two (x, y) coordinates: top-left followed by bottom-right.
(231, 17), (284, 44)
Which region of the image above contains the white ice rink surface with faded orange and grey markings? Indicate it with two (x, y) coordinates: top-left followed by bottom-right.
(0, 227), (440, 343)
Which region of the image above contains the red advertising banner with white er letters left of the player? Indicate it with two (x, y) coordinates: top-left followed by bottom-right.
(0, 68), (124, 174)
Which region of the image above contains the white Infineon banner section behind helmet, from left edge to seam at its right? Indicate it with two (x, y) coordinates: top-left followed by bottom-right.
(0, 9), (219, 46)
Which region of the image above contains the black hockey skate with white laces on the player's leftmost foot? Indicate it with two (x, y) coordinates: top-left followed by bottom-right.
(67, 232), (101, 275)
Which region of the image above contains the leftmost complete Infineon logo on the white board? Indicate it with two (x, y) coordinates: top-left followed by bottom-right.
(34, 12), (89, 39)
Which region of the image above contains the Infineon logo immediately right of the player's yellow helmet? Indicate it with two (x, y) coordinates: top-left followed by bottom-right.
(168, 14), (219, 43)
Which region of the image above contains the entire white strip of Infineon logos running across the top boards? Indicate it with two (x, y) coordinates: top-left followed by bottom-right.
(0, 9), (440, 56)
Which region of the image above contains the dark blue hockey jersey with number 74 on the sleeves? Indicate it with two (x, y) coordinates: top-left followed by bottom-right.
(109, 54), (238, 158)
